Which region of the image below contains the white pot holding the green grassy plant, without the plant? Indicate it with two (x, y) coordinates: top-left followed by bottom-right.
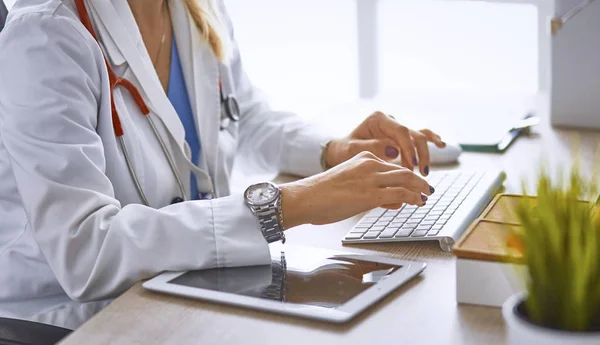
(502, 292), (600, 345)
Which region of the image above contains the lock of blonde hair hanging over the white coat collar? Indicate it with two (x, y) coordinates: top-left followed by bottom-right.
(184, 0), (231, 62)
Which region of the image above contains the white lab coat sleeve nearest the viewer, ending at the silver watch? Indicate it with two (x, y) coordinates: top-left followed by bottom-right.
(0, 14), (270, 301)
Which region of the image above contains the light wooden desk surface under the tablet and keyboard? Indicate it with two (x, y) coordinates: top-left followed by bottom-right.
(63, 94), (600, 345)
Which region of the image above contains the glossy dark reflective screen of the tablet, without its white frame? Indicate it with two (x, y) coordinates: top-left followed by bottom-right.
(169, 252), (402, 308)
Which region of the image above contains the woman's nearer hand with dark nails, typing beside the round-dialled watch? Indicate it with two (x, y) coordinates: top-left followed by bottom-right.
(280, 152), (434, 229)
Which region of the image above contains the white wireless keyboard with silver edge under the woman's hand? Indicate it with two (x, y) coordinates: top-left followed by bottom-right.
(342, 170), (506, 251)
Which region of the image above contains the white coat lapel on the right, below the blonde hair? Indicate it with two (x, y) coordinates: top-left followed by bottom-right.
(169, 0), (220, 177)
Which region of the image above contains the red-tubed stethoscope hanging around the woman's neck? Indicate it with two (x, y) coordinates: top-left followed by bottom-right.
(75, 0), (240, 206)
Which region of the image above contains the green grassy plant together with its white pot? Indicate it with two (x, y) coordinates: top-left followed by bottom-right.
(502, 167), (600, 345)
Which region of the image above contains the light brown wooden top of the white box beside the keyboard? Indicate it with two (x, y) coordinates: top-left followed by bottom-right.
(452, 194), (535, 262)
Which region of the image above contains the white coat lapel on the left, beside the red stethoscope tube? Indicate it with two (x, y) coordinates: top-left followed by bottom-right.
(87, 0), (185, 152)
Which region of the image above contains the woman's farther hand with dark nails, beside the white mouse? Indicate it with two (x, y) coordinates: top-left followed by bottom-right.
(325, 112), (446, 176)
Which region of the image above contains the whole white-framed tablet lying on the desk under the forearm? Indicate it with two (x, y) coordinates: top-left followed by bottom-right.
(143, 245), (426, 323)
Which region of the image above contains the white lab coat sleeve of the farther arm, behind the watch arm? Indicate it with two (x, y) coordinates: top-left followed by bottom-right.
(221, 5), (333, 176)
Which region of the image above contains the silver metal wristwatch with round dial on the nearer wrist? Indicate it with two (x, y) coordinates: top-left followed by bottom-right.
(244, 182), (285, 243)
